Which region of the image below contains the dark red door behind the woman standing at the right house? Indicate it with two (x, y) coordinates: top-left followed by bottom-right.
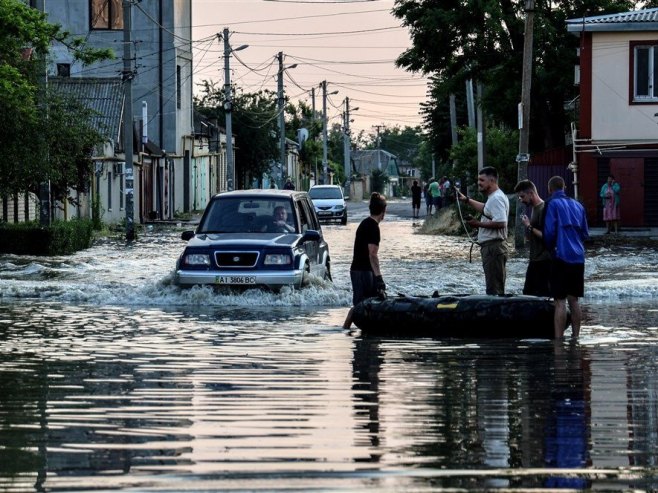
(601, 158), (644, 227)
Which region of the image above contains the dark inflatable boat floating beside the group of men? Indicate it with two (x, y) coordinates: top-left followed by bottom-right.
(352, 293), (569, 339)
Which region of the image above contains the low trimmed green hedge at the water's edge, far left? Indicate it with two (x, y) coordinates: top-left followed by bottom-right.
(0, 219), (93, 255)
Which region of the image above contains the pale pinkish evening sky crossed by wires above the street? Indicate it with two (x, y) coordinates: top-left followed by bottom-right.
(192, 0), (427, 134)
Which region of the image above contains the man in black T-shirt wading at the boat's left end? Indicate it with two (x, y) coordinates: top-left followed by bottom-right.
(343, 192), (386, 329)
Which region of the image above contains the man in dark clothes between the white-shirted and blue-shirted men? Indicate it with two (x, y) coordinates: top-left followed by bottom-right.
(514, 180), (551, 296)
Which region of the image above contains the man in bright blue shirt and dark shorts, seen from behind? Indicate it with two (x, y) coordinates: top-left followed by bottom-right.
(543, 176), (589, 338)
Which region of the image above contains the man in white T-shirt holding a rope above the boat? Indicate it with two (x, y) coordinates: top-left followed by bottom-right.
(457, 166), (509, 295)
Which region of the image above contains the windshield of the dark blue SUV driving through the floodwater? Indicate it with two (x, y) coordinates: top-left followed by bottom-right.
(197, 197), (299, 233)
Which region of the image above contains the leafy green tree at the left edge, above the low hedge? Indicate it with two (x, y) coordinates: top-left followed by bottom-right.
(0, 0), (112, 200)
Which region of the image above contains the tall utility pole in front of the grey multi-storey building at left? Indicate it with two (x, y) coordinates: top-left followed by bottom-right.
(123, 0), (135, 242)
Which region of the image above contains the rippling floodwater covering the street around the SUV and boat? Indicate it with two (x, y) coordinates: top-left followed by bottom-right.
(0, 202), (658, 492)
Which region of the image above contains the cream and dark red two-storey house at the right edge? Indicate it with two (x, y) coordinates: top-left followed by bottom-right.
(567, 9), (658, 227)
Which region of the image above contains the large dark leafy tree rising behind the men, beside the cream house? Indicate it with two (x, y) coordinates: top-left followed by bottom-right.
(393, 0), (645, 151)
